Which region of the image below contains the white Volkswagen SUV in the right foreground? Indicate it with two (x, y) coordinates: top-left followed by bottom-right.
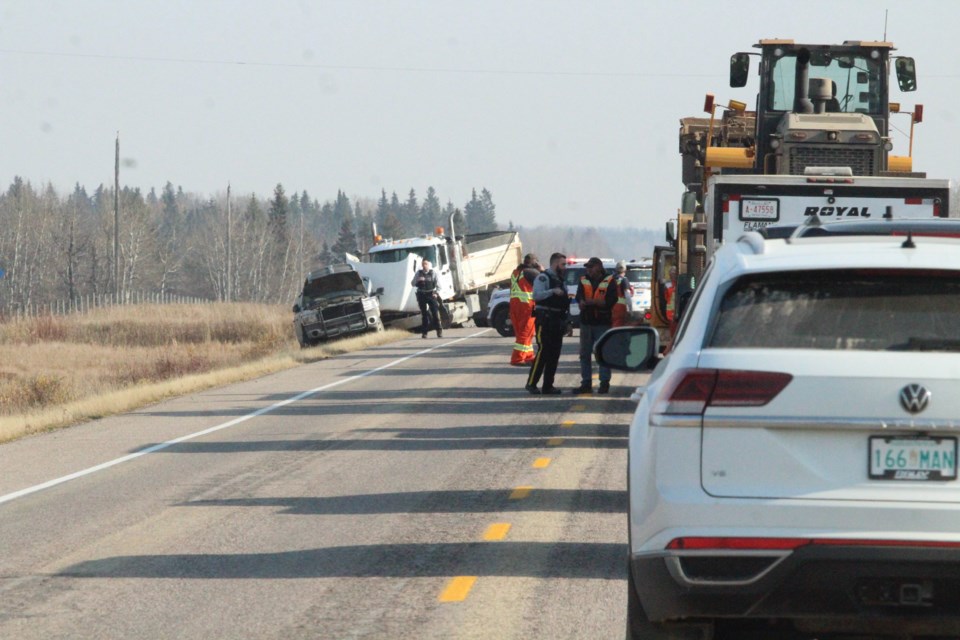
(597, 221), (960, 639)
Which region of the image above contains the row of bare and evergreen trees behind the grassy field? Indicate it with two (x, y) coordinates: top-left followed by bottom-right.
(0, 177), (497, 316)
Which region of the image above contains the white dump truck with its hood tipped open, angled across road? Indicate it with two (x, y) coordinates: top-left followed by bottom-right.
(347, 219), (523, 328)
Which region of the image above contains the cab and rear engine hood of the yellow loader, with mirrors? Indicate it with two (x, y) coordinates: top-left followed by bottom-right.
(730, 40), (916, 176)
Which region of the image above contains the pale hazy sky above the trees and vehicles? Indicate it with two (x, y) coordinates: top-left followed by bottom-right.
(0, 0), (960, 228)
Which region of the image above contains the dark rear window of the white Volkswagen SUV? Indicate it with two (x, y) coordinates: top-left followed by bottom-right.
(708, 269), (960, 352)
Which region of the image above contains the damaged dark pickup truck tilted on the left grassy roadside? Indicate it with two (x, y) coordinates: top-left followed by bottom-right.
(293, 264), (383, 347)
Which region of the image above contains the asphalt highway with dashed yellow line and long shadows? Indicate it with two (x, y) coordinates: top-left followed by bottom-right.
(0, 328), (644, 640)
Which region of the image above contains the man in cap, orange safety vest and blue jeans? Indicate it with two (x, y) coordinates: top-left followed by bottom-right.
(573, 258), (617, 394)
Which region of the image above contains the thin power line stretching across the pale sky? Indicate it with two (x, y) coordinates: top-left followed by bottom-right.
(0, 49), (716, 78)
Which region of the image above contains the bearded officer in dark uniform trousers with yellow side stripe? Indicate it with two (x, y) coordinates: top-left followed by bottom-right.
(526, 253), (570, 395)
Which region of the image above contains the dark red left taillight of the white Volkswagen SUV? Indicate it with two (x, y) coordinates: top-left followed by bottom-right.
(653, 369), (793, 415)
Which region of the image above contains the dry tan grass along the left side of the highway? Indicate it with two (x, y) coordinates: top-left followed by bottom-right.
(0, 303), (409, 442)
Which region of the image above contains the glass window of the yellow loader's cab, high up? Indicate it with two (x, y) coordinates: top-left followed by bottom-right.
(767, 51), (886, 114)
